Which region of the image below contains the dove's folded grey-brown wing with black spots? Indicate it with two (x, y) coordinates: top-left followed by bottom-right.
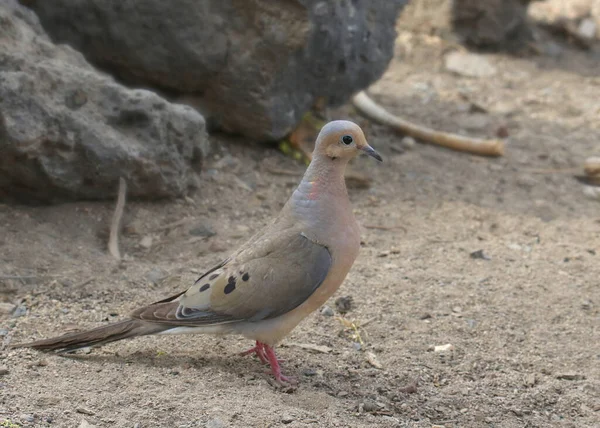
(132, 229), (332, 327)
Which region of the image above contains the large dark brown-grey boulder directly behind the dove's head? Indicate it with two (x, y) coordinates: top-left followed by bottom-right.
(23, 0), (406, 140)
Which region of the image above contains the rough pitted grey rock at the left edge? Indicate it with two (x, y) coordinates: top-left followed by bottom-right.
(0, 0), (208, 202)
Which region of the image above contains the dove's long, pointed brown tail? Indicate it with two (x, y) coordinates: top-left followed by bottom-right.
(12, 319), (172, 352)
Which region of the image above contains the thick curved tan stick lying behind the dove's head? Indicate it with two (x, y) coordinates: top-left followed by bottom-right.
(352, 91), (504, 156)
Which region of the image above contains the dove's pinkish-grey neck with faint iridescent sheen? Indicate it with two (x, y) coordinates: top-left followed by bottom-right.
(291, 157), (350, 210)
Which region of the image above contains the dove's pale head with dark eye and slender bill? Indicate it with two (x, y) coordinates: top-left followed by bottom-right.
(313, 120), (383, 162)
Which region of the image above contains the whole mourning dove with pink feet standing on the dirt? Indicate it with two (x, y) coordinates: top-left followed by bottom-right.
(15, 121), (382, 383)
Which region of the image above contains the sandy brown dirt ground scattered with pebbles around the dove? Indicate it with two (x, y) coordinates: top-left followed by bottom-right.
(0, 15), (600, 428)
